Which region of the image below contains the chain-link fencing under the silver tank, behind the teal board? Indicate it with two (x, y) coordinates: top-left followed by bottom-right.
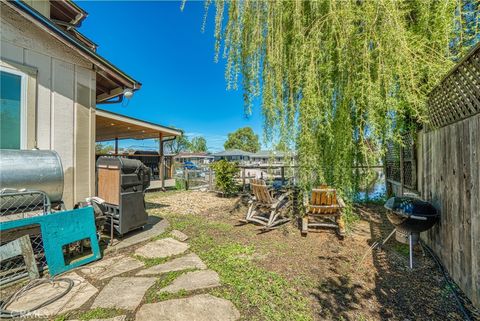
(0, 189), (51, 287)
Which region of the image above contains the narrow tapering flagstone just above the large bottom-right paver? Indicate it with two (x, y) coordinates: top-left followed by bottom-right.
(159, 270), (220, 293)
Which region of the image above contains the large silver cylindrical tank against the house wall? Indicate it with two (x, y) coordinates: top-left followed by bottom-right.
(0, 149), (63, 203)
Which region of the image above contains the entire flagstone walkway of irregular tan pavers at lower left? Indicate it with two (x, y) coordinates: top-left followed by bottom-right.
(11, 225), (240, 321)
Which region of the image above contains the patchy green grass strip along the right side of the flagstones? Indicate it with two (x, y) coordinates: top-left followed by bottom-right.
(159, 214), (313, 321)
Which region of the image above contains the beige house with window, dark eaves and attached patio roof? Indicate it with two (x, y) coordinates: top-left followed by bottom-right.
(0, 0), (181, 208)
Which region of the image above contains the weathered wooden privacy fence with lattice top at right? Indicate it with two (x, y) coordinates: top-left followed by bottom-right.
(417, 44), (480, 307)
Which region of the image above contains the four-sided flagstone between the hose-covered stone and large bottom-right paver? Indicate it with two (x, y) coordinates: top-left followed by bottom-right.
(92, 277), (155, 310)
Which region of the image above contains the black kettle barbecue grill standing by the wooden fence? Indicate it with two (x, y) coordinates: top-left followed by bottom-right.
(384, 197), (440, 268)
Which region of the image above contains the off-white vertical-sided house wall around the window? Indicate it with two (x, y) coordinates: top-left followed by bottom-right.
(0, 3), (96, 208)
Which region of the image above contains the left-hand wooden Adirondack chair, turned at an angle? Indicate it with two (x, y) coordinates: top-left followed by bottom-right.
(242, 179), (291, 230)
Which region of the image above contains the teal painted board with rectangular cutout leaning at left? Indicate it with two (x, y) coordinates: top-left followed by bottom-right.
(0, 207), (101, 276)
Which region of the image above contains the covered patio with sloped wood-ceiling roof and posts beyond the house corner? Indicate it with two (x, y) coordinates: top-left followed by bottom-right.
(95, 108), (183, 189)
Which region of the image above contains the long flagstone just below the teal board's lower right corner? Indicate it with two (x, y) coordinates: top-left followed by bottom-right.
(80, 255), (145, 280)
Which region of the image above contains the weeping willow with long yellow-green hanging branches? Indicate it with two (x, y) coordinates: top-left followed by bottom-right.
(195, 0), (479, 197)
